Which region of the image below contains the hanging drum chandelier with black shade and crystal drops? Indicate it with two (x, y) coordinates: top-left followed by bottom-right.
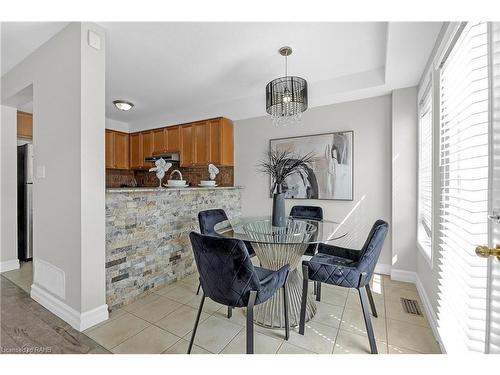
(266, 47), (307, 126)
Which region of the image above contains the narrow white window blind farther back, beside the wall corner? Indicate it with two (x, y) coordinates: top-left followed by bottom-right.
(417, 85), (432, 259)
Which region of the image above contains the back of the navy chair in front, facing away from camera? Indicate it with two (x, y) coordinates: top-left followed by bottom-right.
(189, 232), (260, 307)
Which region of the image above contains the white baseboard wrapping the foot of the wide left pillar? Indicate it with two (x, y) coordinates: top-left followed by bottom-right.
(31, 284), (109, 332)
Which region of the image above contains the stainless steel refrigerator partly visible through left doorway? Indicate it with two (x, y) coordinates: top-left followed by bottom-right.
(17, 144), (33, 260)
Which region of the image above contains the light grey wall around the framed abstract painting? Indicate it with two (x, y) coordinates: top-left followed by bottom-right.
(234, 95), (392, 267)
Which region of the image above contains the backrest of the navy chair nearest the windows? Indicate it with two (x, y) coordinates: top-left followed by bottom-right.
(358, 220), (389, 286)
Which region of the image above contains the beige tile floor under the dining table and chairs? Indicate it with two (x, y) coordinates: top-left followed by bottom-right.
(85, 275), (446, 354)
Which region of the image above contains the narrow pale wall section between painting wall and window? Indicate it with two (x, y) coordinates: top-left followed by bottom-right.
(392, 87), (418, 272)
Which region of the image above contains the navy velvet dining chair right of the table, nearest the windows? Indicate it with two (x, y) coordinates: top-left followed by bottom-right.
(299, 220), (389, 354)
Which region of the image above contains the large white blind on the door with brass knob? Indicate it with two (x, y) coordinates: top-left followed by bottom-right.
(438, 23), (489, 353)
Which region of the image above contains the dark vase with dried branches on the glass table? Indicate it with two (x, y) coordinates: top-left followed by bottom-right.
(258, 148), (314, 227)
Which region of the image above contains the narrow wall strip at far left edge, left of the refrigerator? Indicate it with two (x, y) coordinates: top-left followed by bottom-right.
(0, 106), (19, 272)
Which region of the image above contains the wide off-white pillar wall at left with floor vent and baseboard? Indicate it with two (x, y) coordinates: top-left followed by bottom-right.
(2, 23), (107, 329)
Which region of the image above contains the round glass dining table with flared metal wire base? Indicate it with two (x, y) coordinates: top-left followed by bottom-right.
(214, 216), (347, 328)
